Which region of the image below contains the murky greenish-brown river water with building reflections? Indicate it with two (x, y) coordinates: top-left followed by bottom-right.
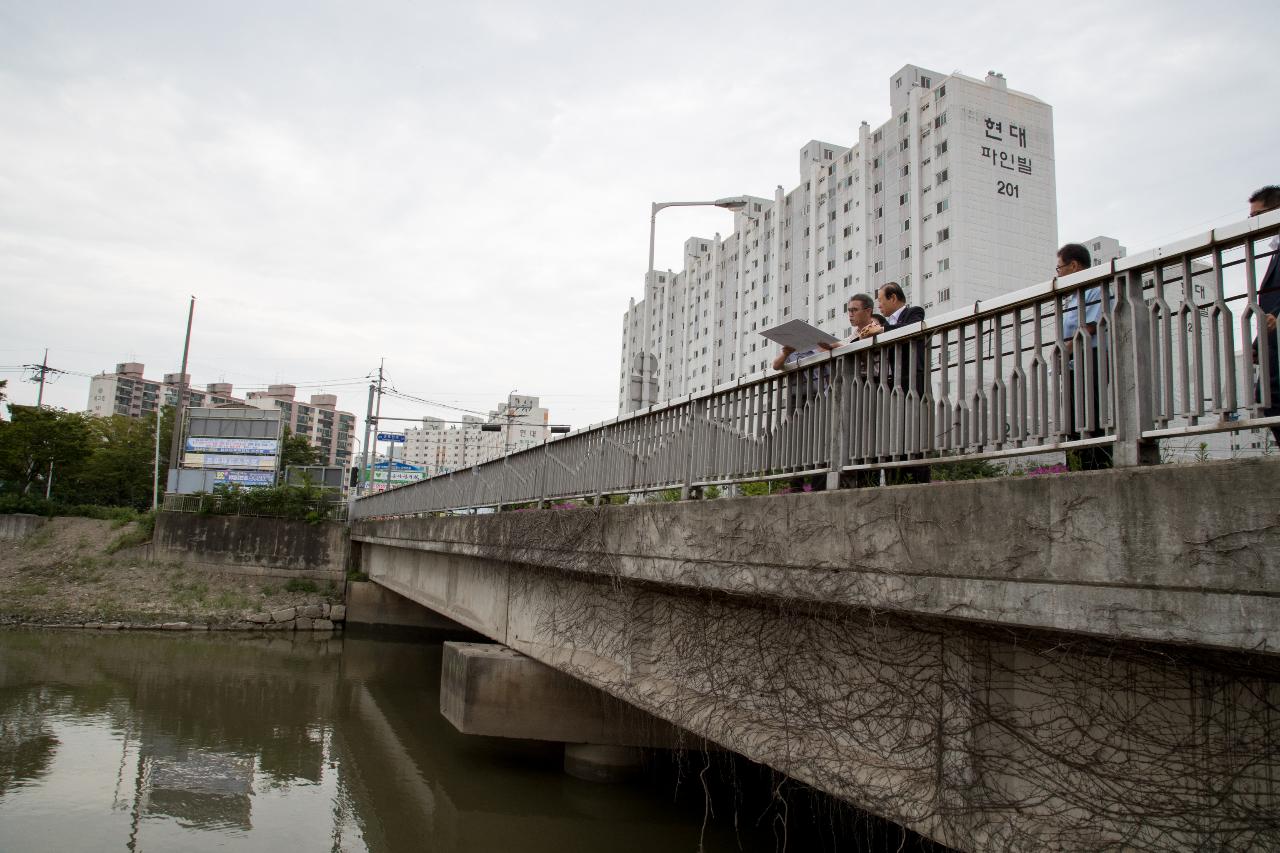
(0, 630), (936, 853)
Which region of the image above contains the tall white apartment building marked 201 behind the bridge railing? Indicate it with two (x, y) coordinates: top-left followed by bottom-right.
(618, 65), (1057, 412)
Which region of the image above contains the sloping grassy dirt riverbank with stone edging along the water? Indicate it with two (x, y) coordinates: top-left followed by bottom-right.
(0, 517), (346, 630)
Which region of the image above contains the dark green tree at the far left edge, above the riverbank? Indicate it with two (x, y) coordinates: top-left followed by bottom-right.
(0, 403), (93, 497)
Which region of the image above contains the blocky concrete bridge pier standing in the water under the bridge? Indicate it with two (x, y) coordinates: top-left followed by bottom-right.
(440, 643), (689, 781)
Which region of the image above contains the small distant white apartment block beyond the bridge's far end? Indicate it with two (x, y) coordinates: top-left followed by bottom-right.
(397, 393), (550, 476)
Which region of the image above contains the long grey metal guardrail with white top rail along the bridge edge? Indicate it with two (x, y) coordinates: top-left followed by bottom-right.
(351, 211), (1280, 519)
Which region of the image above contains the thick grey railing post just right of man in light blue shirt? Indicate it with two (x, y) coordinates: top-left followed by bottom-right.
(1114, 269), (1160, 467)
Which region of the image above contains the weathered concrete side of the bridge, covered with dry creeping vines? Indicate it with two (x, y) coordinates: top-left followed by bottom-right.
(353, 462), (1280, 850)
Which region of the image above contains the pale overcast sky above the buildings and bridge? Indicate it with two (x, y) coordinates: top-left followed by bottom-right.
(0, 0), (1280, 435)
